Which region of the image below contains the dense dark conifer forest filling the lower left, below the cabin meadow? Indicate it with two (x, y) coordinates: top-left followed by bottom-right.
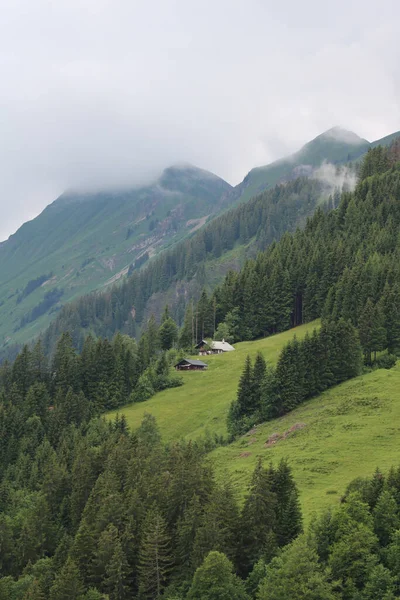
(0, 336), (302, 600)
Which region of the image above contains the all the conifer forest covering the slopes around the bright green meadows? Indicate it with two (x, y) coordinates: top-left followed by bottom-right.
(0, 145), (400, 600)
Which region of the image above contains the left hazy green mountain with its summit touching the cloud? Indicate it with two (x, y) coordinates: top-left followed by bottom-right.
(0, 165), (231, 350)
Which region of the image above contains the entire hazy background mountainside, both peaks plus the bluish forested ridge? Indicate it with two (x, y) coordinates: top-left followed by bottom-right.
(0, 127), (398, 351)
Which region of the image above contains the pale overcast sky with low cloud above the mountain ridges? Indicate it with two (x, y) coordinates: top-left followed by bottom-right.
(0, 0), (400, 240)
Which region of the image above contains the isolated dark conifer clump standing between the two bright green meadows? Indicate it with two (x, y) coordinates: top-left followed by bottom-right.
(227, 319), (362, 437)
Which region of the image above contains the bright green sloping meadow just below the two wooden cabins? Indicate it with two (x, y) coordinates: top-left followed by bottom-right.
(108, 322), (318, 441)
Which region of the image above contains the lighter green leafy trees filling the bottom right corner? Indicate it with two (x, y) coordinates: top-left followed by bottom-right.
(255, 468), (400, 600)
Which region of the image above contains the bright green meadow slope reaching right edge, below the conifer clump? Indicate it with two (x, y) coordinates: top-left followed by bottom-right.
(210, 363), (400, 521)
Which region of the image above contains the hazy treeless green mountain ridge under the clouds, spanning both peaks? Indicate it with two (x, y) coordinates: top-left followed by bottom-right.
(0, 127), (398, 347)
